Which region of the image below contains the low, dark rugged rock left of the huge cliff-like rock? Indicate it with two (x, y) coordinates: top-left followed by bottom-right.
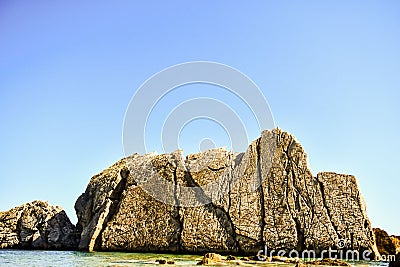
(0, 201), (79, 249)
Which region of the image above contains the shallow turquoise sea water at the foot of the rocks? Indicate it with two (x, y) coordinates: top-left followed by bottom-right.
(0, 250), (387, 267)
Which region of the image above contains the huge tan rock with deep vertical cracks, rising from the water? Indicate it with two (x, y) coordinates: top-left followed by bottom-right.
(75, 129), (377, 253)
